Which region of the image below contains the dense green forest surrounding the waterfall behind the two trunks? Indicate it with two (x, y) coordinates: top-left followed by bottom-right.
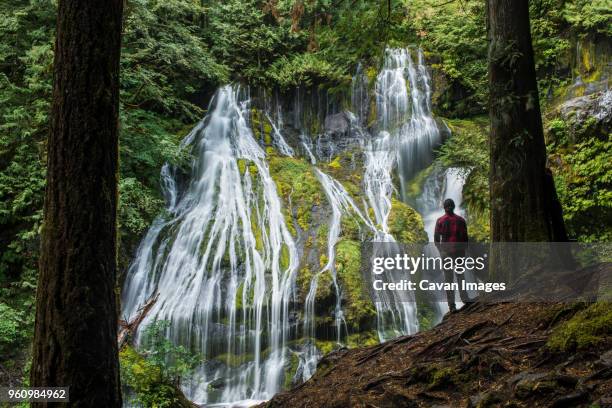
(0, 0), (612, 396)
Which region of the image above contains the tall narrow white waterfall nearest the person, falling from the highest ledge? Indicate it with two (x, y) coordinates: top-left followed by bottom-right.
(364, 49), (441, 341)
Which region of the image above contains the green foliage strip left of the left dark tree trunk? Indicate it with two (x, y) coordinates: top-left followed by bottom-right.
(0, 0), (55, 281)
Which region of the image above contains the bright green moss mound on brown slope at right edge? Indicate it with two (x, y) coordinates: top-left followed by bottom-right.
(547, 302), (612, 351)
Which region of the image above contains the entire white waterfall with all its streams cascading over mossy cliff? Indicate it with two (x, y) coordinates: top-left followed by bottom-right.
(123, 49), (463, 406)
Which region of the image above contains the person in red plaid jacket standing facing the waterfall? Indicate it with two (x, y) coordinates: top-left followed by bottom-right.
(434, 198), (469, 312)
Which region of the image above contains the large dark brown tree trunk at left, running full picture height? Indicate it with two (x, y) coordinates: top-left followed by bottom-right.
(31, 0), (123, 407)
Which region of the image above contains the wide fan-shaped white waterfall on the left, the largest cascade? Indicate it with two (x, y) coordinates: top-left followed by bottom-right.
(123, 86), (298, 403)
